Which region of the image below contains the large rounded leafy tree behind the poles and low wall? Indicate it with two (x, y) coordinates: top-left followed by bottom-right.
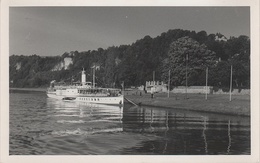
(162, 36), (217, 85)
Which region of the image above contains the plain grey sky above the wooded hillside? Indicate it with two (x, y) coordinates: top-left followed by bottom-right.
(9, 7), (250, 56)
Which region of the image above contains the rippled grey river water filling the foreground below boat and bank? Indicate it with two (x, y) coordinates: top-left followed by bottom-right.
(9, 91), (251, 155)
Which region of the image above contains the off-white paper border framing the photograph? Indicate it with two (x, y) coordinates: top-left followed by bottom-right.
(0, 0), (260, 163)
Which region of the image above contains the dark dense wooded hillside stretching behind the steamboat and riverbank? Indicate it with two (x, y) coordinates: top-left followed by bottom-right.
(9, 29), (250, 88)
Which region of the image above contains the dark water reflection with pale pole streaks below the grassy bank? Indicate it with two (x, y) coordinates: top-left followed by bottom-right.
(123, 108), (250, 154)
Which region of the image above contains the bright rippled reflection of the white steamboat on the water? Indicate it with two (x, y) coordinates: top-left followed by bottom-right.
(47, 98), (123, 136)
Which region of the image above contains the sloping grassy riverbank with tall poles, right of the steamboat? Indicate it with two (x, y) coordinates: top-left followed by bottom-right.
(125, 92), (250, 116)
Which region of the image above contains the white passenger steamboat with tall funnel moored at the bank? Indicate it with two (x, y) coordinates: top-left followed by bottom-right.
(47, 69), (124, 105)
